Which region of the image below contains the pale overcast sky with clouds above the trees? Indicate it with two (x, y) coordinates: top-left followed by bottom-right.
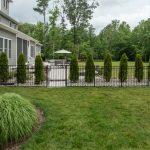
(10, 0), (150, 33)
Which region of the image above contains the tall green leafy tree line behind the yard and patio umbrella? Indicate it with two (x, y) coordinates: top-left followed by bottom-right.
(19, 0), (150, 61)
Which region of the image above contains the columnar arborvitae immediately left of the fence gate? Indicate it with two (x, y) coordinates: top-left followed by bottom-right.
(35, 55), (44, 84)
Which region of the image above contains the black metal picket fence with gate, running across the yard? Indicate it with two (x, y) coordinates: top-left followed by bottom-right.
(0, 66), (150, 87)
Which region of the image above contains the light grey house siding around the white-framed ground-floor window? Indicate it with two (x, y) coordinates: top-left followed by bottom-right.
(0, 28), (17, 65)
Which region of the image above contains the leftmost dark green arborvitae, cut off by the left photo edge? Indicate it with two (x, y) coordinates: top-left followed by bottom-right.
(0, 53), (9, 82)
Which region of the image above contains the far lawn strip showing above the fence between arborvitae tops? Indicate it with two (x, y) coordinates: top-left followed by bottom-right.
(79, 61), (148, 66)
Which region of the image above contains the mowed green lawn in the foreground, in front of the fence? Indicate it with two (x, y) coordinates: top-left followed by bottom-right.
(0, 87), (150, 150)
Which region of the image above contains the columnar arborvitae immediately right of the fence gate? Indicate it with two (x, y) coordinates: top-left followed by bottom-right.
(70, 54), (79, 82)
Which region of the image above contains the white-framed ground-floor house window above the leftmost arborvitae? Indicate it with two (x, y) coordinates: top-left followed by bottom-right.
(0, 37), (12, 58)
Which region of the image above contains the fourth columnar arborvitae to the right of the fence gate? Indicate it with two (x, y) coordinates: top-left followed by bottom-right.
(119, 54), (128, 82)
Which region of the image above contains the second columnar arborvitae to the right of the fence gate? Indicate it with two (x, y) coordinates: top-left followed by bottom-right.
(85, 54), (95, 83)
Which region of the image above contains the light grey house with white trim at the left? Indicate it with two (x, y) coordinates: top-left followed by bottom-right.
(0, 0), (42, 65)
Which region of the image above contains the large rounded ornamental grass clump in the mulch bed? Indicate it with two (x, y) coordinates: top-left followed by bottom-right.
(0, 93), (37, 148)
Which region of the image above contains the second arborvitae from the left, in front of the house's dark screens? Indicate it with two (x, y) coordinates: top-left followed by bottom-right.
(17, 54), (26, 84)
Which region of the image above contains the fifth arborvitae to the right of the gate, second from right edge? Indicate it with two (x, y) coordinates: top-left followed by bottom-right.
(135, 54), (144, 82)
